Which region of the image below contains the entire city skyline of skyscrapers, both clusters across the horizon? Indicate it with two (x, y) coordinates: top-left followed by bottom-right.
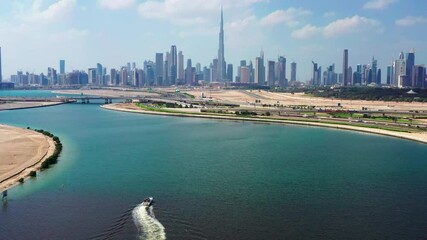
(0, 9), (427, 88)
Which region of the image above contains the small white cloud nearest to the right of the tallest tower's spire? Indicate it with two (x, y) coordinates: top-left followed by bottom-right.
(261, 7), (311, 27)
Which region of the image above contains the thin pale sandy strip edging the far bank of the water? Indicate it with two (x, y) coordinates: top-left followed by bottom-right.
(101, 104), (427, 144)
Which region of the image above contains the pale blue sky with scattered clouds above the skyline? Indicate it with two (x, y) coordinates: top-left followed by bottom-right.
(0, 0), (427, 81)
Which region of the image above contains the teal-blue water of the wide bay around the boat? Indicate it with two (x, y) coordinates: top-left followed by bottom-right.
(0, 90), (427, 239)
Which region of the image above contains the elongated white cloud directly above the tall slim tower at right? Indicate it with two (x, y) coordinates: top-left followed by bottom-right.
(323, 15), (382, 38)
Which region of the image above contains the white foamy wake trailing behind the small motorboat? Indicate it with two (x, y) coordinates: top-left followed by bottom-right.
(132, 203), (166, 240)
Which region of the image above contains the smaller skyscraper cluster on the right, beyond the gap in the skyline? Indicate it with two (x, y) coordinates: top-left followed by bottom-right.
(310, 49), (427, 88)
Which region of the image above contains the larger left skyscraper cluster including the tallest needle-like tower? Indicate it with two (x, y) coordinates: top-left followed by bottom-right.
(4, 9), (296, 87)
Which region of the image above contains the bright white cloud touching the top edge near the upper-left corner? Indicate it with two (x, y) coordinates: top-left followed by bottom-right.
(18, 0), (76, 23)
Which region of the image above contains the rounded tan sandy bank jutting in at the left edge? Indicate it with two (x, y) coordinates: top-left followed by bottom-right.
(0, 124), (55, 191)
